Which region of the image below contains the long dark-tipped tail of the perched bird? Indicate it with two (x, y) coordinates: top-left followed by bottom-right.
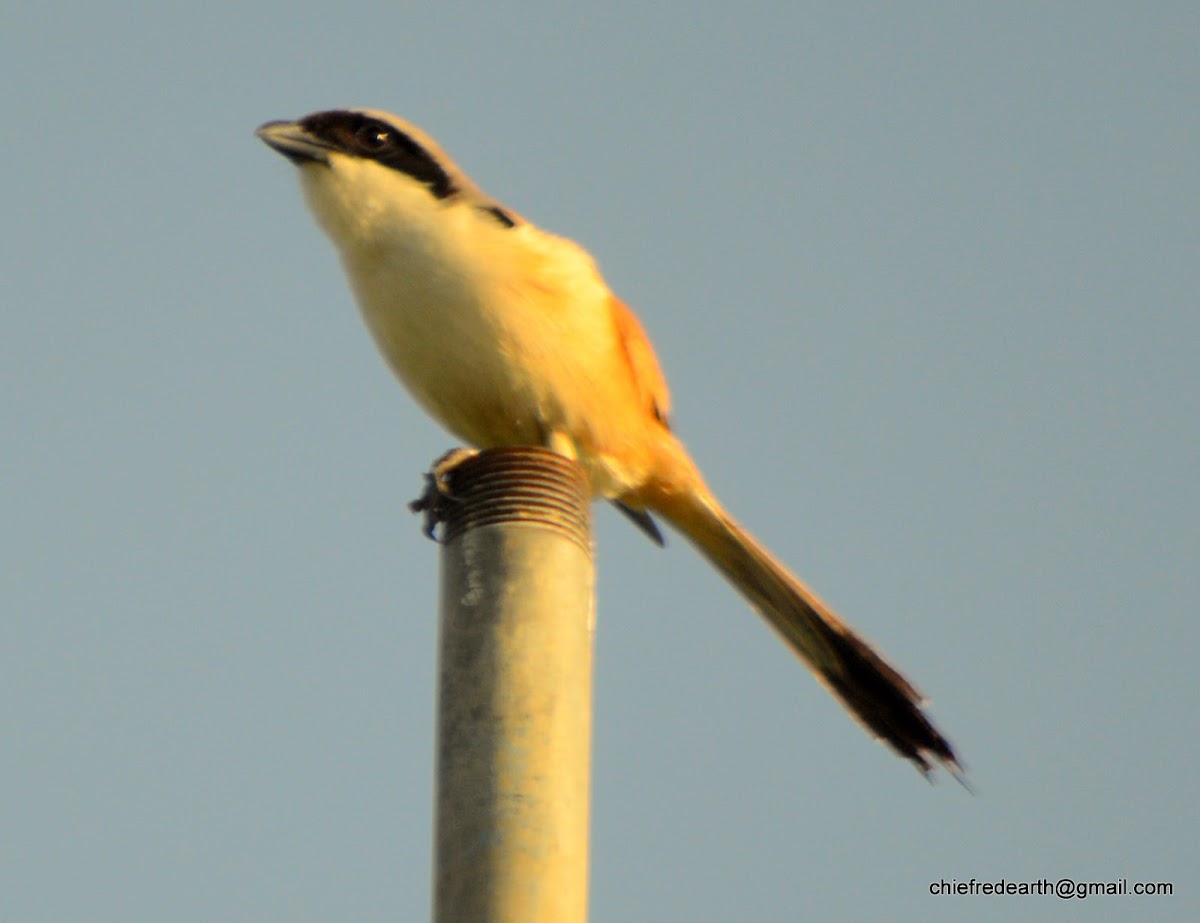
(660, 484), (966, 785)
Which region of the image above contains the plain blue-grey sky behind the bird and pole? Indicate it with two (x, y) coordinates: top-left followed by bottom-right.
(0, 0), (1200, 923)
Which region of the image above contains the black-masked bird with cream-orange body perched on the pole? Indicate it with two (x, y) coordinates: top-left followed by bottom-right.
(257, 109), (966, 785)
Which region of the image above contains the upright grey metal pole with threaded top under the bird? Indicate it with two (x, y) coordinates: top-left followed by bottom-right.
(433, 448), (595, 923)
